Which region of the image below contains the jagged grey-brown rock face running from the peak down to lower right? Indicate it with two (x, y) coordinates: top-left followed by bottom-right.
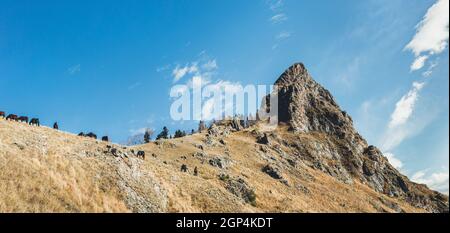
(262, 63), (448, 212)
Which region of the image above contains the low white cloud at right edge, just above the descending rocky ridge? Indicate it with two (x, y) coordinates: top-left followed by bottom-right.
(411, 171), (449, 195)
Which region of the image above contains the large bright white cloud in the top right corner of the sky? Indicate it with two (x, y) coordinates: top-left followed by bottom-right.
(405, 0), (449, 70)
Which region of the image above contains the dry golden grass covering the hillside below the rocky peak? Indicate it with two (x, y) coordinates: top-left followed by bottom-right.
(0, 119), (428, 212)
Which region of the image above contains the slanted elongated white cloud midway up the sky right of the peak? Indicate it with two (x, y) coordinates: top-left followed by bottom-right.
(389, 82), (425, 129)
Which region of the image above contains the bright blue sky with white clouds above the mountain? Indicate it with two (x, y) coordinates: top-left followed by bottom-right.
(0, 0), (449, 193)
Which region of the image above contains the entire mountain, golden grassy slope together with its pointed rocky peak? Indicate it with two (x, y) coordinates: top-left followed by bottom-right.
(0, 63), (449, 212)
